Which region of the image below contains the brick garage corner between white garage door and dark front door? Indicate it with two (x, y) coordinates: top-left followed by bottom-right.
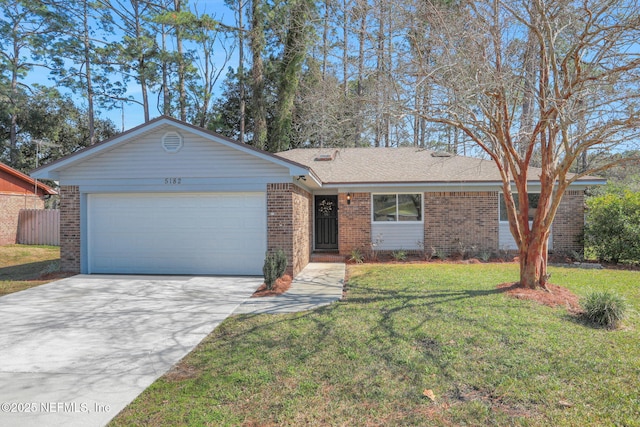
(267, 184), (312, 276)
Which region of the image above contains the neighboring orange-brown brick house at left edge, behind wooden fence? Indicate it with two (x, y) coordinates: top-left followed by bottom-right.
(0, 163), (57, 246)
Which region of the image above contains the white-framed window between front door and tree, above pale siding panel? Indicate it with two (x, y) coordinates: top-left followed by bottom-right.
(371, 193), (422, 223)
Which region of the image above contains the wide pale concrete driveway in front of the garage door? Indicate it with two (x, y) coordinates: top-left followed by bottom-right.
(0, 275), (263, 426)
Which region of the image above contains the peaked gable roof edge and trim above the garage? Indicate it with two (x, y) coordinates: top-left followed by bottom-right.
(31, 116), (313, 180)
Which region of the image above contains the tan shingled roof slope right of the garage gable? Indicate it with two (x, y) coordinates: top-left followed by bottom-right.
(277, 147), (605, 185)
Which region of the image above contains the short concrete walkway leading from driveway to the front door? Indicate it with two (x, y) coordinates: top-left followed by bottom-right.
(233, 262), (345, 314)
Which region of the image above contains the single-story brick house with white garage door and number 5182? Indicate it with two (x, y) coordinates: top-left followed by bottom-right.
(32, 117), (604, 275)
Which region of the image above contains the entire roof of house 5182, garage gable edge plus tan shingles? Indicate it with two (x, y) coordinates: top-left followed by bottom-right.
(28, 116), (606, 188)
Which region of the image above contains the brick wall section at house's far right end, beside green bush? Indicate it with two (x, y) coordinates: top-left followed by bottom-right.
(552, 190), (584, 253)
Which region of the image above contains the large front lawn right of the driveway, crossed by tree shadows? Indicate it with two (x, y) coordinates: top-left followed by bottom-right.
(112, 264), (640, 426)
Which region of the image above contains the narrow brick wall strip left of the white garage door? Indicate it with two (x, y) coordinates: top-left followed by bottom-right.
(60, 185), (80, 273)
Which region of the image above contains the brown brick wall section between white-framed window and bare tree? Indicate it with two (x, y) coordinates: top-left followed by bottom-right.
(424, 191), (498, 253)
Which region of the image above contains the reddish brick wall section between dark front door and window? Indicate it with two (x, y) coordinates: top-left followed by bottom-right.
(338, 193), (371, 255)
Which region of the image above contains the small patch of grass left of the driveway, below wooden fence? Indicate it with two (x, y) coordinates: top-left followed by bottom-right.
(0, 245), (60, 296)
